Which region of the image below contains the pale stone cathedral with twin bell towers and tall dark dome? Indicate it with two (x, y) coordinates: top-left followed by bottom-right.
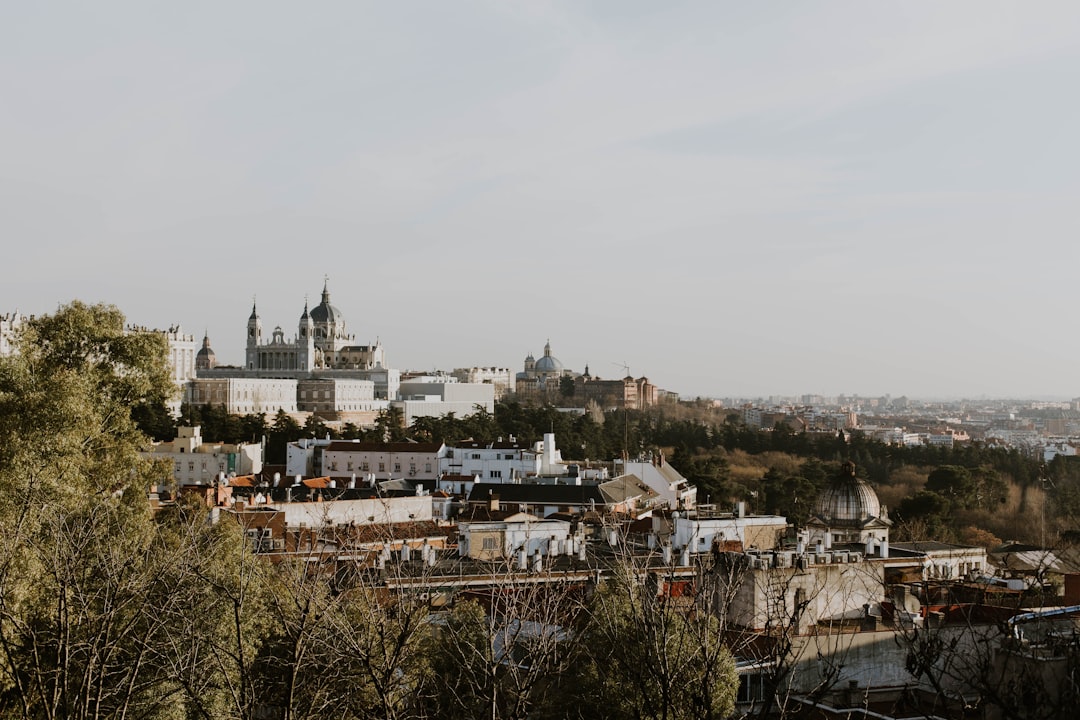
(244, 283), (386, 372)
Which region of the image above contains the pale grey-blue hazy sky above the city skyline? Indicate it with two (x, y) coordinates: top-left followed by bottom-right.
(0, 0), (1080, 397)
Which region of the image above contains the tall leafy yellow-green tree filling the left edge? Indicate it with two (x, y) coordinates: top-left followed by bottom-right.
(0, 302), (179, 718)
